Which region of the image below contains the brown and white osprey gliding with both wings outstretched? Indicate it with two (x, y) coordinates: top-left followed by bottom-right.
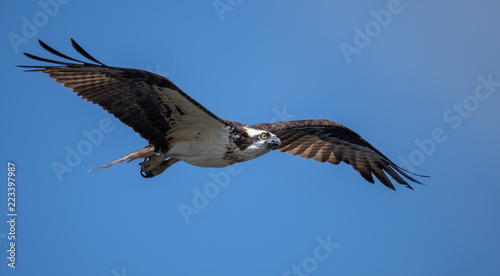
(20, 39), (421, 190)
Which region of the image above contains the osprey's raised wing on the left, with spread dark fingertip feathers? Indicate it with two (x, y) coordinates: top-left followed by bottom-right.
(20, 39), (228, 151)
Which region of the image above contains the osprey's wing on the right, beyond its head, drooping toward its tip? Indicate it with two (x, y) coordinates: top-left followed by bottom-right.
(251, 120), (421, 190)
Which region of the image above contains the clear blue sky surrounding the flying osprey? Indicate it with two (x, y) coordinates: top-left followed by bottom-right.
(0, 0), (500, 276)
